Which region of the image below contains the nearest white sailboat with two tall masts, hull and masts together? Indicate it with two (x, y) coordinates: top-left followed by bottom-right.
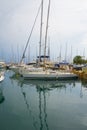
(19, 0), (77, 80)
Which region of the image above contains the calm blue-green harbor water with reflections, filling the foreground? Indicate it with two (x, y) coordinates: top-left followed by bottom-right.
(0, 71), (87, 130)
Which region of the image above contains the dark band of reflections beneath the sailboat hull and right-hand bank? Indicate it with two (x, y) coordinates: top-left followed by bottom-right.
(10, 74), (87, 98)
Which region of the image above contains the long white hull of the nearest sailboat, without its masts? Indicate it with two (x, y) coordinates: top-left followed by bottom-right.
(20, 69), (78, 80)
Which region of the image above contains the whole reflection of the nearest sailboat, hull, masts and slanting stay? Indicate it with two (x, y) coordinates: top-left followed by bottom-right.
(10, 72), (81, 130)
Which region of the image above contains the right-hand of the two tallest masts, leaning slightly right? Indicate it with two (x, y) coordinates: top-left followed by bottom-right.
(44, 0), (50, 65)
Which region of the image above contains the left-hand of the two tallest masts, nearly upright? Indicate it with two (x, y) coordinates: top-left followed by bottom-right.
(39, 0), (43, 64)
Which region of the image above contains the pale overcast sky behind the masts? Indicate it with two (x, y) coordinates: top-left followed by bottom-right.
(0, 0), (87, 62)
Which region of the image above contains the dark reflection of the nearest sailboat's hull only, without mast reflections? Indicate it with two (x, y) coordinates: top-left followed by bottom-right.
(10, 74), (78, 91)
